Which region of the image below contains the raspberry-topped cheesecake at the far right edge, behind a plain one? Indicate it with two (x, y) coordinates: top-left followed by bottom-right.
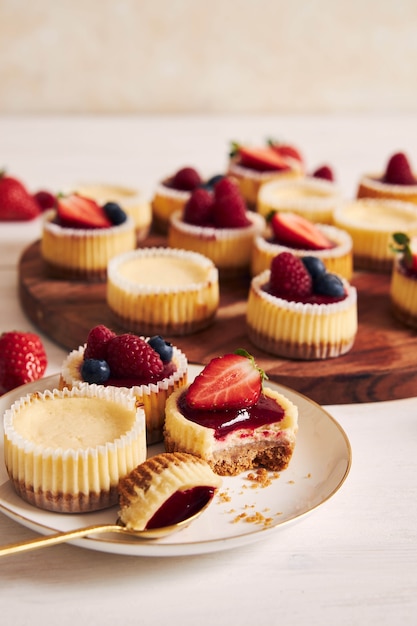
(357, 152), (417, 204)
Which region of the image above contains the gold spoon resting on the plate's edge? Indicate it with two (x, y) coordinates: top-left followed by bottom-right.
(0, 498), (211, 556)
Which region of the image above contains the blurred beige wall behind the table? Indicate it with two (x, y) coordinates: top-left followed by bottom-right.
(0, 0), (417, 114)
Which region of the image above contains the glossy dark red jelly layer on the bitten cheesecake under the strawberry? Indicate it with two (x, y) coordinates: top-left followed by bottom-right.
(178, 391), (284, 439)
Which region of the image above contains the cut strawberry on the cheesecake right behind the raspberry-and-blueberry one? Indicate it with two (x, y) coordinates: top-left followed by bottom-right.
(269, 211), (333, 250)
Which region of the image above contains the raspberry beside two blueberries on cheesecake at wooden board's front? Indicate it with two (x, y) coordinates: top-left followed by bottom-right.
(270, 252), (313, 300)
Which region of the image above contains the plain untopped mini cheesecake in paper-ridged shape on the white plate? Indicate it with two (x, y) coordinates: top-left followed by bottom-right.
(4, 385), (146, 513)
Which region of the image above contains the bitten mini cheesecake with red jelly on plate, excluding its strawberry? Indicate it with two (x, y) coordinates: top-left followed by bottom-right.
(164, 387), (298, 476)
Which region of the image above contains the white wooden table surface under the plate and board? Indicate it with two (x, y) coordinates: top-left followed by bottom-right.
(0, 117), (417, 626)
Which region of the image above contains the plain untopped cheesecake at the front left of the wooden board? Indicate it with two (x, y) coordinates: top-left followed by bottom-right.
(106, 247), (219, 335)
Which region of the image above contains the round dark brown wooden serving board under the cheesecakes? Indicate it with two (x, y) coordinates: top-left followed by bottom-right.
(19, 236), (417, 404)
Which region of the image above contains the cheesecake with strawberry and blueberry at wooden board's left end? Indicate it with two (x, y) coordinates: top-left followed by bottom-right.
(41, 194), (136, 282)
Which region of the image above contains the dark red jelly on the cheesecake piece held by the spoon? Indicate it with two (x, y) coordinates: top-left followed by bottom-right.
(146, 486), (216, 530)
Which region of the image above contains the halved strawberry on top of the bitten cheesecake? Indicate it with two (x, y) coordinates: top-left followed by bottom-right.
(186, 350), (264, 411)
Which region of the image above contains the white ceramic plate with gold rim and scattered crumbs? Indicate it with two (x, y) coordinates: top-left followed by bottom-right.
(0, 366), (351, 556)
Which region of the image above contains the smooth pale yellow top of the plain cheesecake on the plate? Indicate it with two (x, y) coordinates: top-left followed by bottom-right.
(13, 397), (136, 449)
